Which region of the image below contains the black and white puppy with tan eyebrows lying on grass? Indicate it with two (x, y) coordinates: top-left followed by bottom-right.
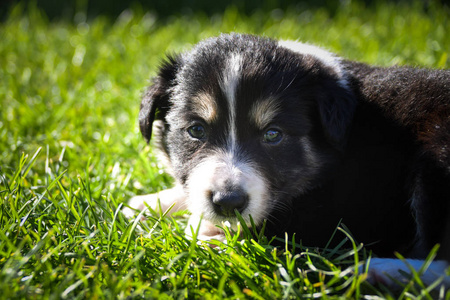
(125, 34), (450, 284)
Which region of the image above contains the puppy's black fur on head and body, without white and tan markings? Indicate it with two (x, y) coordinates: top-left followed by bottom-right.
(139, 35), (450, 260)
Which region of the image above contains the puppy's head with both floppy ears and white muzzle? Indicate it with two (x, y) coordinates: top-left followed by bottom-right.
(139, 34), (355, 224)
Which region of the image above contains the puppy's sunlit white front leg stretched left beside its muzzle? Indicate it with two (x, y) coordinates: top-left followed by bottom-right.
(123, 185), (186, 218)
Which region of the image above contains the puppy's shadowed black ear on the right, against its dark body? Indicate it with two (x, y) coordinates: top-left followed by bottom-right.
(318, 82), (356, 150)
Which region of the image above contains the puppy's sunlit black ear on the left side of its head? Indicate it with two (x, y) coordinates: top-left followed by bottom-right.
(139, 56), (180, 143)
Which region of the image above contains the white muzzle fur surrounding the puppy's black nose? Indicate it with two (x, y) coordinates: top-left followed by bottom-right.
(187, 152), (269, 229)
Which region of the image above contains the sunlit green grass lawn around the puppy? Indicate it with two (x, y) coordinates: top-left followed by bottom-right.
(0, 1), (450, 299)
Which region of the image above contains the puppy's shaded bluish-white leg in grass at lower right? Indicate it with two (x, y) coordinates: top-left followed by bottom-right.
(368, 258), (450, 288)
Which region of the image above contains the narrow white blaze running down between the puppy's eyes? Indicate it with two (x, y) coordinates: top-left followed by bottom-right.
(221, 53), (242, 151)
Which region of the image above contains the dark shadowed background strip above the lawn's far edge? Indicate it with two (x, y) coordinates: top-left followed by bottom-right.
(0, 0), (450, 20)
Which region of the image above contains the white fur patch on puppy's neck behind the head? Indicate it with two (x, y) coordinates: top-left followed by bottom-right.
(278, 41), (349, 89)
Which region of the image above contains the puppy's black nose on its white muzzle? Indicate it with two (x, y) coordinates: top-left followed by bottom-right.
(212, 190), (248, 217)
